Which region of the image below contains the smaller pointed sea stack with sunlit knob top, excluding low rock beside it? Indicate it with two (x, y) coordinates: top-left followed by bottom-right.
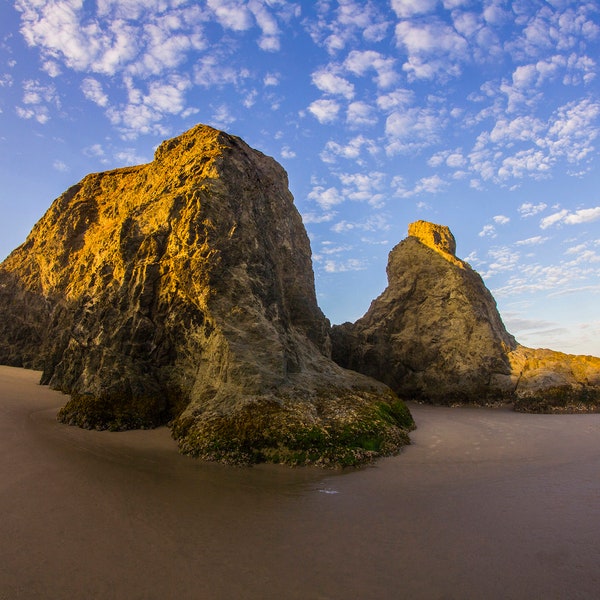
(332, 221), (516, 403)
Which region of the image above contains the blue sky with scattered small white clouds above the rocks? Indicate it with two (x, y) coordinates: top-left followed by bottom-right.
(0, 0), (600, 356)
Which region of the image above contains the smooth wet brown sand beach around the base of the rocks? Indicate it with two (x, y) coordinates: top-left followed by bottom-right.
(0, 367), (600, 600)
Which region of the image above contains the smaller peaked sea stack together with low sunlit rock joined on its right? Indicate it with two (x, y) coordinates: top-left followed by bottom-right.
(332, 221), (600, 411)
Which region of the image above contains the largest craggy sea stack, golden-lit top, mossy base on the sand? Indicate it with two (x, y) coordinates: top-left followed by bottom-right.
(0, 125), (412, 464)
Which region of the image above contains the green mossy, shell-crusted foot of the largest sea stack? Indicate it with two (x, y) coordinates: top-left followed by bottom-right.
(173, 393), (414, 467)
